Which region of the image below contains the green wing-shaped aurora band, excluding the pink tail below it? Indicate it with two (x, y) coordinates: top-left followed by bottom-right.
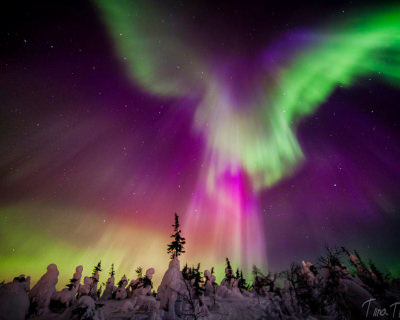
(95, 0), (400, 192)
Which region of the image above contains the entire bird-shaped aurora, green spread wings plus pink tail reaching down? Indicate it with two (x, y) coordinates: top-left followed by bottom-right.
(92, 0), (400, 276)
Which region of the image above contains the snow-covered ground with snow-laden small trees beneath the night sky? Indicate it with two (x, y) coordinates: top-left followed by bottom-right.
(0, 255), (400, 320)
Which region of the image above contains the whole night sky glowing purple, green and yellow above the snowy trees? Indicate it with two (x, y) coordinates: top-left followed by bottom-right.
(0, 0), (400, 284)
